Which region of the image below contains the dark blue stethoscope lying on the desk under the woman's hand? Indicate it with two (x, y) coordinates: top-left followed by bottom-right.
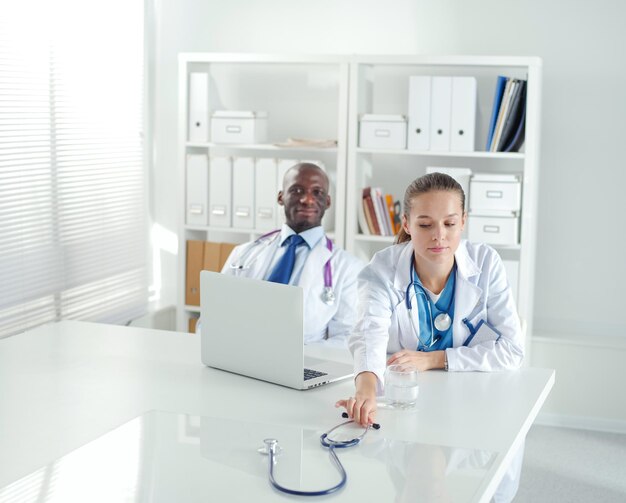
(259, 412), (380, 496)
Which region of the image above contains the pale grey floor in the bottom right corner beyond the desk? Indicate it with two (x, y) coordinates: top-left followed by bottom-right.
(514, 425), (626, 503)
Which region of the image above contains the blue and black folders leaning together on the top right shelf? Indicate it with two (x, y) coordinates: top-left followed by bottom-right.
(485, 75), (527, 152)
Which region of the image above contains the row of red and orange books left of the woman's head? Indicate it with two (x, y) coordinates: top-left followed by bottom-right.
(358, 187), (400, 236)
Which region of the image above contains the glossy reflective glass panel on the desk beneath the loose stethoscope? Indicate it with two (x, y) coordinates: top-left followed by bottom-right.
(0, 411), (496, 503)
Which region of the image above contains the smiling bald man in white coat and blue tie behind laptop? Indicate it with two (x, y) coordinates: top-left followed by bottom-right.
(222, 162), (364, 345)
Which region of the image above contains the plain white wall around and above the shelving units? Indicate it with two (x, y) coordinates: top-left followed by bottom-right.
(147, 0), (626, 430)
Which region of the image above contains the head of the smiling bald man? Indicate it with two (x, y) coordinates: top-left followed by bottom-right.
(278, 165), (330, 233)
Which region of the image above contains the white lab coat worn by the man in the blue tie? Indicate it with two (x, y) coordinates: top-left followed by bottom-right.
(222, 236), (365, 347)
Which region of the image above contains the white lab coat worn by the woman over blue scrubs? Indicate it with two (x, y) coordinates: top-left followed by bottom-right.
(349, 240), (524, 383)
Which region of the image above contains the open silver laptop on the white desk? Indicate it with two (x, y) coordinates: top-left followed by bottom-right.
(200, 271), (353, 389)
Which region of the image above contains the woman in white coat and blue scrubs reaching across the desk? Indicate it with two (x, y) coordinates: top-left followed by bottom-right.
(336, 173), (524, 426)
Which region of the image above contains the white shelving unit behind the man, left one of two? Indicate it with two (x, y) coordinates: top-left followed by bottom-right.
(177, 53), (349, 331)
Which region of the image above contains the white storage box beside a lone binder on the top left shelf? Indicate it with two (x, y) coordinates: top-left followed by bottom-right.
(211, 110), (267, 143)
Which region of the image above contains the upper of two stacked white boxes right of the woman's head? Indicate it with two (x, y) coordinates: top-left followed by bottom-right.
(469, 173), (522, 213)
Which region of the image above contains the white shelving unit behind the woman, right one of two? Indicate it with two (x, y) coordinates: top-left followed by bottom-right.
(345, 56), (541, 346)
